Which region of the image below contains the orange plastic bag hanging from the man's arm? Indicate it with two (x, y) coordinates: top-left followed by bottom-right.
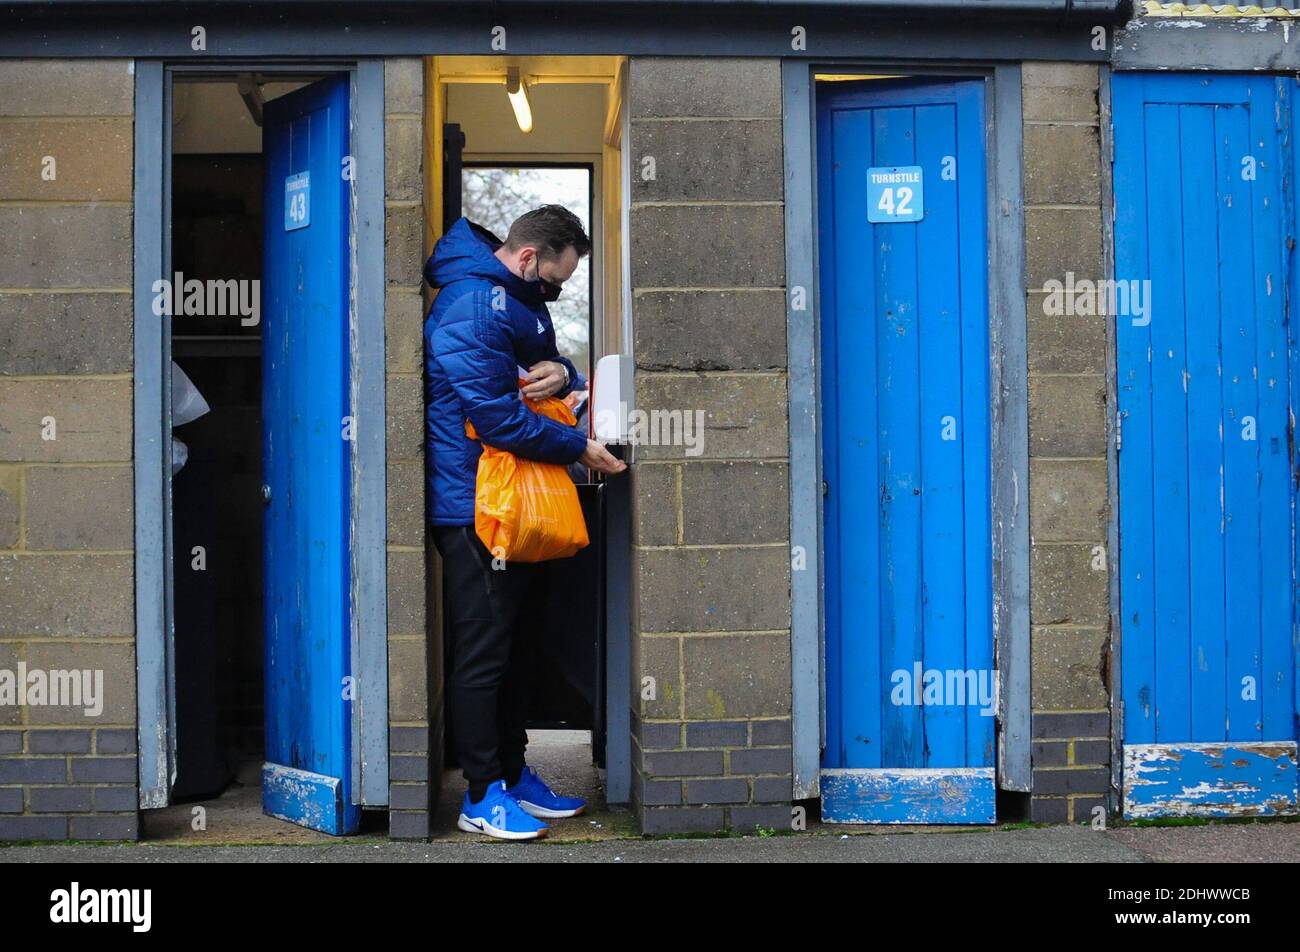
(465, 397), (590, 562)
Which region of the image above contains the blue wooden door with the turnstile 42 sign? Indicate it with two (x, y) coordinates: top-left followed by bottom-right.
(816, 79), (996, 823)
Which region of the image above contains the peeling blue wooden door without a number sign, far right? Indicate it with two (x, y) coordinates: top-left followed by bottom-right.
(1112, 74), (1296, 817)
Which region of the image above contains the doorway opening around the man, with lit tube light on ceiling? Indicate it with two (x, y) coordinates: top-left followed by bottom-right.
(425, 56), (631, 826)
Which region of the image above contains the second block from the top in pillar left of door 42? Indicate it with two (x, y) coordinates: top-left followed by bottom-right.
(632, 118), (785, 202)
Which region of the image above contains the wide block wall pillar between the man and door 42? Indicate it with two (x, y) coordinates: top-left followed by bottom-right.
(628, 57), (792, 834)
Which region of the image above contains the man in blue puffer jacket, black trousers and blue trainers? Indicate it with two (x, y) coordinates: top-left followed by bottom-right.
(424, 205), (627, 839)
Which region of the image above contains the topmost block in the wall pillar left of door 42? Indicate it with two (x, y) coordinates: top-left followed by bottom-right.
(629, 56), (781, 118)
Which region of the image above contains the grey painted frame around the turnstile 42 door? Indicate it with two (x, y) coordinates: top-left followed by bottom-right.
(781, 60), (1031, 800)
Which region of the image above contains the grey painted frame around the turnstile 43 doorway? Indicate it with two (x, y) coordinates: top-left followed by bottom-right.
(133, 59), (389, 809)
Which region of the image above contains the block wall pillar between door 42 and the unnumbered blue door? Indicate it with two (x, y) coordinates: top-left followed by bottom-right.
(1022, 62), (1110, 823)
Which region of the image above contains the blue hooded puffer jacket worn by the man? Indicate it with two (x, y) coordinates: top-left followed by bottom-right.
(424, 218), (586, 525)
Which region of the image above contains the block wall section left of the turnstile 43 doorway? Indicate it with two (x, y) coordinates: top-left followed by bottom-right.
(0, 60), (139, 840)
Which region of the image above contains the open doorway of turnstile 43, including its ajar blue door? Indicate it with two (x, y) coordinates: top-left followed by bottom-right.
(142, 72), (382, 840)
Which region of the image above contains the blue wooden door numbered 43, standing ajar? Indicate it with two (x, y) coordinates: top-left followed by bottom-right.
(263, 77), (361, 834)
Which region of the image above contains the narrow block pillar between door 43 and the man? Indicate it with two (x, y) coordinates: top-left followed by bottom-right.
(384, 57), (441, 839)
